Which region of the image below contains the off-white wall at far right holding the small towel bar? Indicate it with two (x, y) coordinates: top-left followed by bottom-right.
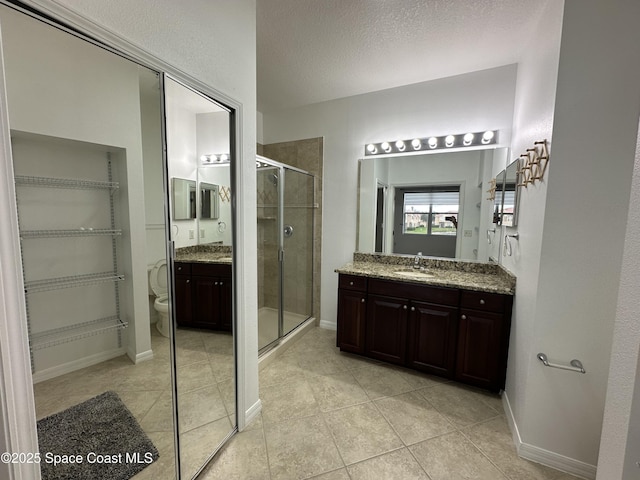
(508, 0), (640, 476)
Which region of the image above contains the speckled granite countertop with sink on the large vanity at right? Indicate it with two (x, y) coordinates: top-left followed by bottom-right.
(336, 254), (516, 295)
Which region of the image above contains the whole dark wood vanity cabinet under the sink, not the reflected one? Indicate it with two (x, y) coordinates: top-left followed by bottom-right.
(337, 274), (512, 391)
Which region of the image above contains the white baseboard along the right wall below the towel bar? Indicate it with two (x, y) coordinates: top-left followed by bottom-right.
(502, 392), (597, 480)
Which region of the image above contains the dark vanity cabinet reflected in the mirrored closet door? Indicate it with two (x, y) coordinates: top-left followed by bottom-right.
(175, 262), (232, 331)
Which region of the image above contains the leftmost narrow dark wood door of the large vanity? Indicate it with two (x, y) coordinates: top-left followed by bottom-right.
(337, 289), (367, 353)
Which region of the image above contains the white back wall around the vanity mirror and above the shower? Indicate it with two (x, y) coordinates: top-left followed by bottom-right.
(263, 65), (516, 325)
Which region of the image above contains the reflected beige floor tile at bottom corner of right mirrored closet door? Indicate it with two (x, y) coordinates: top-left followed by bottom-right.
(180, 417), (231, 478)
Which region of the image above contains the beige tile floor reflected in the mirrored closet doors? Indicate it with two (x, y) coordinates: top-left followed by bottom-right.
(33, 327), (235, 480)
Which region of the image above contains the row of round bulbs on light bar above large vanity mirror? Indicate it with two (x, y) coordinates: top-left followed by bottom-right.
(364, 130), (498, 157)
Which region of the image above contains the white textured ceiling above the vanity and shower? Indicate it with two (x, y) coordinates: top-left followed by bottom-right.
(256, 0), (554, 113)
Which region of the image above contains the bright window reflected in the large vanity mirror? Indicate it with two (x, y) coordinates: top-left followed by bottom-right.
(402, 186), (460, 235)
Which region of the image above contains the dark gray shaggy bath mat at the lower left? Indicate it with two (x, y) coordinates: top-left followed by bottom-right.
(38, 392), (159, 480)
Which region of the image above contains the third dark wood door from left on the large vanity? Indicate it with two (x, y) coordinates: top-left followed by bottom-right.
(407, 301), (458, 378)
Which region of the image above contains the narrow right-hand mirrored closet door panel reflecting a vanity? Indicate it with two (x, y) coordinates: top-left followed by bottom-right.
(165, 77), (236, 478)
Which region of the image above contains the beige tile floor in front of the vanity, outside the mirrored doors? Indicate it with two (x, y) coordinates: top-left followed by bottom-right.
(199, 328), (577, 480)
